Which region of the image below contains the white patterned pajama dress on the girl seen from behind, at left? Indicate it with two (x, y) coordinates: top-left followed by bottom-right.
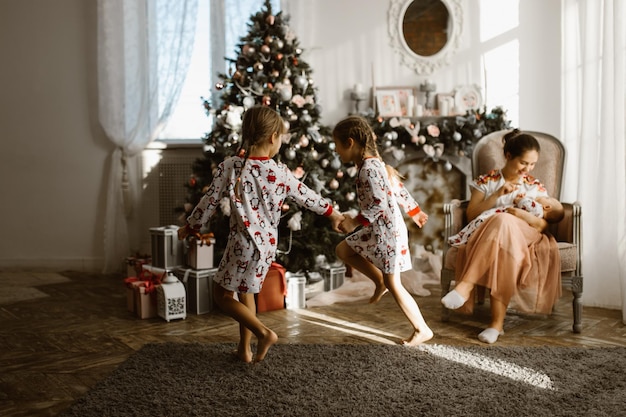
(187, 156), (333, 294)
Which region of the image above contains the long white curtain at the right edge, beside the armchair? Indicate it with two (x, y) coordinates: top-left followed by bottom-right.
(562, 0), (626, 323)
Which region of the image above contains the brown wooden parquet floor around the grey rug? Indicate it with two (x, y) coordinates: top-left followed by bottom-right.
(0, 271), (626, 417)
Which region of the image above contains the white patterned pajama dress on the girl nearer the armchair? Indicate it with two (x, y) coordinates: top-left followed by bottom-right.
(346, 158), (420, 273)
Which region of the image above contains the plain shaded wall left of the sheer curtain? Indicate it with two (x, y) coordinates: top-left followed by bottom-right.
(0, 0), (110, 270)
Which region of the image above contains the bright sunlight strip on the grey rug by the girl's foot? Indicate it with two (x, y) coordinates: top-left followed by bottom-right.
(417, 345), (556, 391)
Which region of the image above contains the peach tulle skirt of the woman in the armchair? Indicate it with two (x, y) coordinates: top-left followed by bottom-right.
(455, 213), (561, 314)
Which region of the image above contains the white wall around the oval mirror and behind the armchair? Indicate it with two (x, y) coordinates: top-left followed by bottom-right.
(285, 0), (561, 137)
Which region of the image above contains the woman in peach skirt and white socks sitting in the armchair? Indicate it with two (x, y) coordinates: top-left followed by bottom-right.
(441, 129), (561, 343)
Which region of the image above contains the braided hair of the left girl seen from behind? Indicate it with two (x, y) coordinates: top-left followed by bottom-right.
(235, 106), (287, 198)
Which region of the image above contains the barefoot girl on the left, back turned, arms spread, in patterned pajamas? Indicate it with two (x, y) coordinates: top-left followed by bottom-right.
(178, 106), (343, 362)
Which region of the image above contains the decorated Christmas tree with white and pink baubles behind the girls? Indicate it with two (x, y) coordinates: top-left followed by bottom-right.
(185, 0), (356, 272)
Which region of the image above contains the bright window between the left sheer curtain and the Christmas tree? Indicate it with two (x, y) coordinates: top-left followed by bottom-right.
(158, 0), (280, 141)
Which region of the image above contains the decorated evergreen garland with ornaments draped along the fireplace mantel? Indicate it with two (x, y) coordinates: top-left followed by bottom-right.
(365, 107), (511, 168)
